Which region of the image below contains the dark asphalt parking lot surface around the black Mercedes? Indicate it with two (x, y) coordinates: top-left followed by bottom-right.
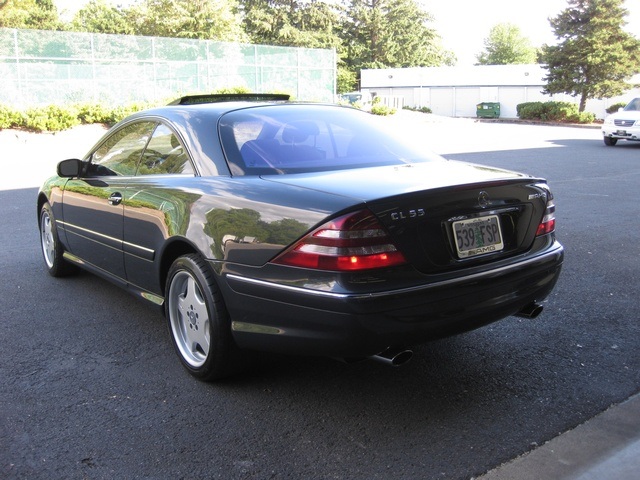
(0, 112), (640, 479)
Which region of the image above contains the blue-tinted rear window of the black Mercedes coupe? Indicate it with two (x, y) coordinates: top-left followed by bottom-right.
(219, 105), (439, 175)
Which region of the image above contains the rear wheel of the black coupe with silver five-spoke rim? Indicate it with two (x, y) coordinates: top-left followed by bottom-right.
(165, 254), (245, 381)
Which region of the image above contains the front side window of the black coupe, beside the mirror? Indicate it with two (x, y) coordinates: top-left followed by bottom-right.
(88, 122), (155, 175)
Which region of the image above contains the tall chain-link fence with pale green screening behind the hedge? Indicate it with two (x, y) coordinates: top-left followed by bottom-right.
(0, 28), (336, 108)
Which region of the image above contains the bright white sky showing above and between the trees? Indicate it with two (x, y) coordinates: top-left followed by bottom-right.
(54, 0), (640, 66)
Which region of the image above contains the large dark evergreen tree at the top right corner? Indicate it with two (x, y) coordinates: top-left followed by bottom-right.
(543, 0), (640, 112)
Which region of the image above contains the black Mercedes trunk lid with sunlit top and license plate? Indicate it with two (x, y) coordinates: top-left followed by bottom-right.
(269, 162), (548, 273)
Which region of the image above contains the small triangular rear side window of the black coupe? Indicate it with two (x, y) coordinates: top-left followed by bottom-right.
(138, 124), (194, 175)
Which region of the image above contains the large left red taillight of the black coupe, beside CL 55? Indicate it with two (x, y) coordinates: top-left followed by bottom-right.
(273, 210), (406, 271)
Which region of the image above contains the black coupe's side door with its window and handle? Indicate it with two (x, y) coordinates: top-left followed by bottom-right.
(63, 121), (155, 279)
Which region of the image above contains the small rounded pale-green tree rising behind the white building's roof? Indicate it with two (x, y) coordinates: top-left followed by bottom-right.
(476, 23), (538, 65)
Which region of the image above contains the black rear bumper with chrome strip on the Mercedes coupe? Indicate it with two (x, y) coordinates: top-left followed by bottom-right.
(223, 242), (564, 357)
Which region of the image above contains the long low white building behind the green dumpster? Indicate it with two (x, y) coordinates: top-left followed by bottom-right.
(361, 64), (640, 118)
